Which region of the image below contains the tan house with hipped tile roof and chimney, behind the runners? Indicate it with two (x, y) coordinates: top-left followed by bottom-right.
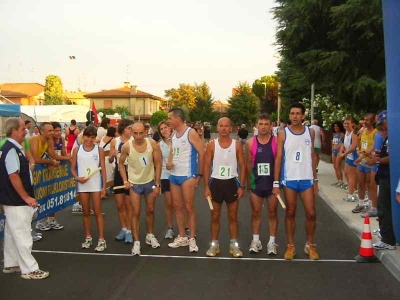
(84, 82), (163, 121)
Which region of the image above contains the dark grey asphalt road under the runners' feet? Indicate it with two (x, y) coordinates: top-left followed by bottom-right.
(0, 188), (400, 300)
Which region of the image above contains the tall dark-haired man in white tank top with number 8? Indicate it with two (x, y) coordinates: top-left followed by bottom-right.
(272, 103), (319, 260)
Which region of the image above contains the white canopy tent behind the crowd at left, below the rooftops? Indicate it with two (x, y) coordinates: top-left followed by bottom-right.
(21, 105), (89, 123)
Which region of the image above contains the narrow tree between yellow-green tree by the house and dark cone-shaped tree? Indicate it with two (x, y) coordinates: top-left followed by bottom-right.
(189, 82), (220, 124)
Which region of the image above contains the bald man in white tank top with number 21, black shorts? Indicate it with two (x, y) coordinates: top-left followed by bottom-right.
(204, 118), (246, 257)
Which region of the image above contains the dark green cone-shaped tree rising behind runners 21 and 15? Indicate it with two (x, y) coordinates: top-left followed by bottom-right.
(228, 82), (260, 125)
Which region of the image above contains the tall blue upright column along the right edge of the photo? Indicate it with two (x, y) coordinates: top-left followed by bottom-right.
(383, 0), (400, 243)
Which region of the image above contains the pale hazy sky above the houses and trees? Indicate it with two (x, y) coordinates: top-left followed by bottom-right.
(0, 0), (278, 101)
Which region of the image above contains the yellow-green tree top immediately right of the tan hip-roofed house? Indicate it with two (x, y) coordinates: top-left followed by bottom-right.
(165, 83), (196, 109)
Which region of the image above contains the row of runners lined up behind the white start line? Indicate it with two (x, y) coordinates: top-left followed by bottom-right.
(72, 103), (319, 260)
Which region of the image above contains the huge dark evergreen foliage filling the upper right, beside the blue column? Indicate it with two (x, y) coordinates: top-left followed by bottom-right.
(274, 0), (386, 111)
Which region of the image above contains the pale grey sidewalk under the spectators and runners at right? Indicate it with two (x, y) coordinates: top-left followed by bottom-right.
(318, 160), (400, 281)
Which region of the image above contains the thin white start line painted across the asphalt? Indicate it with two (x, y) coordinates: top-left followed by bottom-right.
(32, 250), (356, 263)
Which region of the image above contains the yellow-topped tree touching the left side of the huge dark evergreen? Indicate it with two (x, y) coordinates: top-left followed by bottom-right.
(252, 75), (279, 113)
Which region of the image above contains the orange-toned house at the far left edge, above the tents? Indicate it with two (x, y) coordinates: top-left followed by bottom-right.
(0, 82), (44, 105)
